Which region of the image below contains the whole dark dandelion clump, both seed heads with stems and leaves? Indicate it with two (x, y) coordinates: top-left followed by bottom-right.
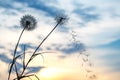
(8, 15), (68, 80)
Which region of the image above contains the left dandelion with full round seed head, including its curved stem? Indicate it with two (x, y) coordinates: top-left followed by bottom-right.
(8, 15), (36, 80)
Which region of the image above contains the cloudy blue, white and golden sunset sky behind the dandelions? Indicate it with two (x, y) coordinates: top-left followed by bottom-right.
(0, 0), (120, 80)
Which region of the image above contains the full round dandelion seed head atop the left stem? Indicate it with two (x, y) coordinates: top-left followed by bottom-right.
(20, 15), (37, 31)
